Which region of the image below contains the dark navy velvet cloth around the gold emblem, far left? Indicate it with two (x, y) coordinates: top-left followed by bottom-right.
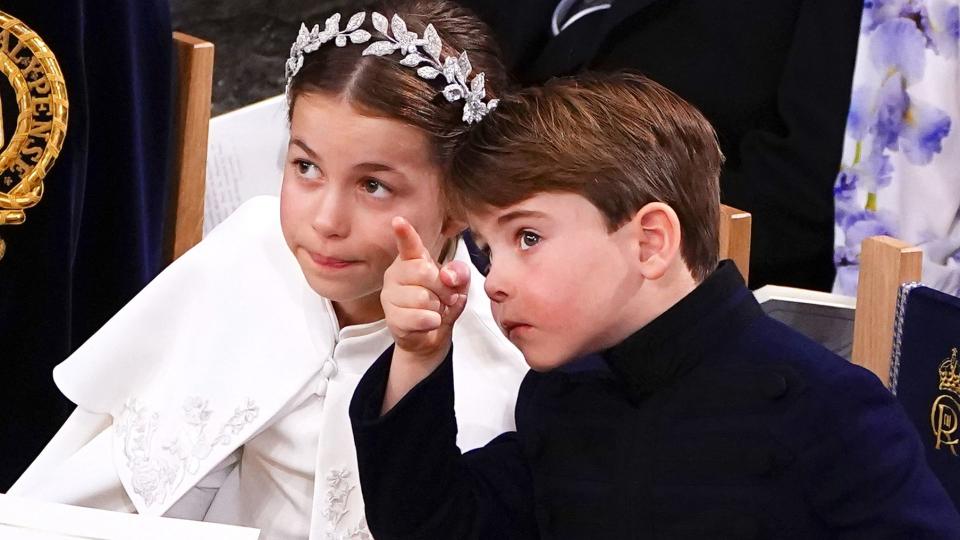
(0, 0), (172, 491)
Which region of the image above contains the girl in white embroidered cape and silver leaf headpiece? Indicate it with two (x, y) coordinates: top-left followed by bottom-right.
(10, 0), (525, 539)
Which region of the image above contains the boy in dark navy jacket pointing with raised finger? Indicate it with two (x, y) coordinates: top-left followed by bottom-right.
(350, 74), (960, 540)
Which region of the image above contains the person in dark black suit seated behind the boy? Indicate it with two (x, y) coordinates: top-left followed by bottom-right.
(461, 0), (863, 291)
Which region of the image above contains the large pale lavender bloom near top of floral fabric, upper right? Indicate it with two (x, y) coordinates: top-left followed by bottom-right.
(870, 18), (927, 85)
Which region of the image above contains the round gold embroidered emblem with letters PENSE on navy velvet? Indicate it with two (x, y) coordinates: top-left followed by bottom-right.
(0, 11), (68, 259)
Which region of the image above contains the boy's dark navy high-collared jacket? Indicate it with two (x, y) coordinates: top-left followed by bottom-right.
(350, 262), (960, 540)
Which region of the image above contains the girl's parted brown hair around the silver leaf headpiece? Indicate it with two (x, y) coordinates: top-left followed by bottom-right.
(289, 0), (507, 173)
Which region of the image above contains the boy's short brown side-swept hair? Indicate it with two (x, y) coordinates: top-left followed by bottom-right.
(450, 73), (723, 281)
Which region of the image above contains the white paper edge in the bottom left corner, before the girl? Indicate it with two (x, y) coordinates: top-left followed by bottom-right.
(0, 495), (260, 540)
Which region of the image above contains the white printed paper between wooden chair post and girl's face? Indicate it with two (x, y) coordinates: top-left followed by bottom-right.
(203, 95), (289, 234)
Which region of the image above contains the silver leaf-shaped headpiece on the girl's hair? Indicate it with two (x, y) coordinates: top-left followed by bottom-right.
(286, 12), (499, 124)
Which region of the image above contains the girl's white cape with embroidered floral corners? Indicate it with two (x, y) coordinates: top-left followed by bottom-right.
(10, 197), (526, 538)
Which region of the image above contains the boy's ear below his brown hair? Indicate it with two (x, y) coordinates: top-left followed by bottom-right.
(631, 202), (680, 279)
